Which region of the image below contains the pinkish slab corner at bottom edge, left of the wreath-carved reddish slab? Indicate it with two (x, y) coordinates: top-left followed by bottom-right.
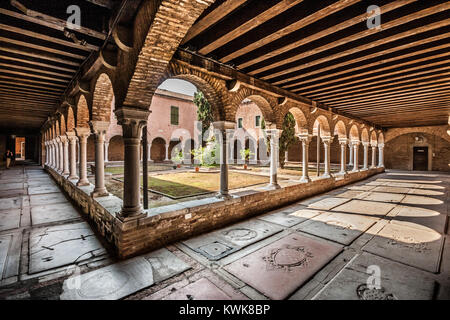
(164, 278), (231, 300)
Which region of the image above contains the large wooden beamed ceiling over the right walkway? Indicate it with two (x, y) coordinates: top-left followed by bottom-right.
(181, 0), (450, 127)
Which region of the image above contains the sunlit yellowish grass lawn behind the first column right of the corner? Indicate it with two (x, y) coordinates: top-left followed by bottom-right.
(142, 172), (269, 198)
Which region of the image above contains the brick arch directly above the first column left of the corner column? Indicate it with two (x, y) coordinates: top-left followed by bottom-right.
(92, 73), (115, 122)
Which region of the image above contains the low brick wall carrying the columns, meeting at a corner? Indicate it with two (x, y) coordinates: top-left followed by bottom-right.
(47, 168), (384, 258)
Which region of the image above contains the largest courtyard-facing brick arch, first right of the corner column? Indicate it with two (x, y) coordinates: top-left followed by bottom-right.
(163, 63), (230, 121)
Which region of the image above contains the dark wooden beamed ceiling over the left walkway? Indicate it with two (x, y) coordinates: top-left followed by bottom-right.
(0, 0), (120, 130)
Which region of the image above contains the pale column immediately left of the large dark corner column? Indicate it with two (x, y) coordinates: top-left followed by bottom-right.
(89, 121), (109, 198)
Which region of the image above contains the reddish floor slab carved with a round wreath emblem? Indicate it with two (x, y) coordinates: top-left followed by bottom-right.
(224, 234), (342, 300)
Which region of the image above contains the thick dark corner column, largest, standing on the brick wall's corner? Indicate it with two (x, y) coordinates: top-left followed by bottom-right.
(114, 107), (150, 221)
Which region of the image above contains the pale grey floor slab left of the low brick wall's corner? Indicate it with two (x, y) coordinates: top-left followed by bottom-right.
(29, 222), (106, 274)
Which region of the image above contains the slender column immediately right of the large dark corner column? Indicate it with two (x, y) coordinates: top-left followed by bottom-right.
(213, 121), (235, 199)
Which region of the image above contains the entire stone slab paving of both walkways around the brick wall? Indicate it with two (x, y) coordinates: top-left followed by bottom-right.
(0, 165), (450, 300)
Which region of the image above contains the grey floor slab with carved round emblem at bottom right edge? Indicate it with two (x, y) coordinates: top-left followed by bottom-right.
(312, 252), (435, 300)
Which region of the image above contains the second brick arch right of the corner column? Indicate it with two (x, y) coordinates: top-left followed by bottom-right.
(227, 87), (275, 122)
